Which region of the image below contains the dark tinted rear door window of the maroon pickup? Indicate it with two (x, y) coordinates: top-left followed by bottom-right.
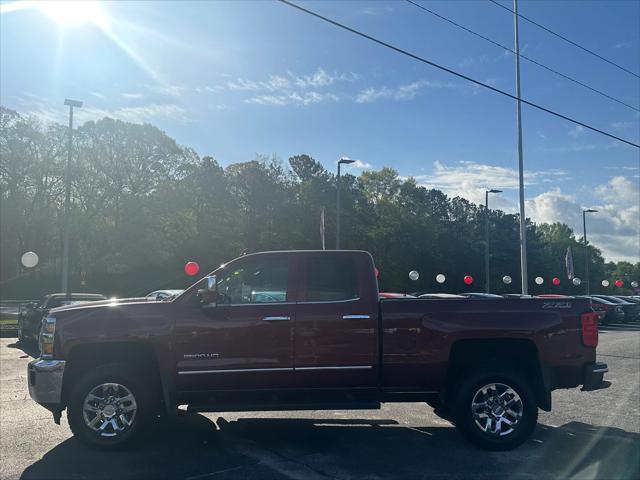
(306, 255), (359, 302)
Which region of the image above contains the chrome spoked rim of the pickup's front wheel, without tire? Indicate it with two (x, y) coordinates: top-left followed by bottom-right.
(82, 383), (138, 437)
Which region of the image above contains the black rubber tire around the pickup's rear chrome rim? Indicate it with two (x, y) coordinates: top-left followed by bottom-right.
(453, 364), (538, 451)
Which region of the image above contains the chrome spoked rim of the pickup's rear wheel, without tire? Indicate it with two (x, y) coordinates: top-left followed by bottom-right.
(471, 383), (524, 436)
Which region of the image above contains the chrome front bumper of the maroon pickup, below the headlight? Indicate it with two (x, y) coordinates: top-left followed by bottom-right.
(28, 358), (66, 411)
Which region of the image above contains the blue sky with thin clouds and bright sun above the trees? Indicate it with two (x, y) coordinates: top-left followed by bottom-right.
(0, 0), (640, 261)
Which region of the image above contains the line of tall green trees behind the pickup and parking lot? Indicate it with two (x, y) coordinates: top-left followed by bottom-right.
(0, 107), (640, 298)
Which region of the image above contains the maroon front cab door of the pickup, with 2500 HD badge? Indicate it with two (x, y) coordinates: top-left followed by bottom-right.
(175, 254), (296, 392)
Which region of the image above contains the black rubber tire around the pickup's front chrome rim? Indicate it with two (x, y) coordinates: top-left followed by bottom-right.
(67, 364), (154, 450)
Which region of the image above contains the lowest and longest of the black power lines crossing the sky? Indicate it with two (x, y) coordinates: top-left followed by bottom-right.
(279, 0), (640, 148)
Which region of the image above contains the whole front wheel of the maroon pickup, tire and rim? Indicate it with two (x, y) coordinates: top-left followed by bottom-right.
(67, 364), (150, 449)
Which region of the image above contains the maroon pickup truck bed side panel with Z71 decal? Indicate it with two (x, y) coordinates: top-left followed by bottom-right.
(380, 299), (595, 391)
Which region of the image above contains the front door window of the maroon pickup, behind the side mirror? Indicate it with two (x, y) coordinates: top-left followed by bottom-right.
(218, 258), (290, 304)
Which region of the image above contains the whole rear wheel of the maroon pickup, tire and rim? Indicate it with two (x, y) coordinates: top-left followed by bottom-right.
(454, 365), (538, 451)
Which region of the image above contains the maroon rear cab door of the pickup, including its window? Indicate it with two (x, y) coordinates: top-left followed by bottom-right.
(294, 252), (378, 389)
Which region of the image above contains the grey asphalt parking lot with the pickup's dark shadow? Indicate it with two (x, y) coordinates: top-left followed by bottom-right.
(0, 325), (640, 480)
